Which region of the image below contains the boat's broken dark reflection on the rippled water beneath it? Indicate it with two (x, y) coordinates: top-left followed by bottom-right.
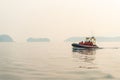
(72, 49), (97, 69)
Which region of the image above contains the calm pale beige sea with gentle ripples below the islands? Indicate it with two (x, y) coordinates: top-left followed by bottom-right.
(0, 42), (120, 80)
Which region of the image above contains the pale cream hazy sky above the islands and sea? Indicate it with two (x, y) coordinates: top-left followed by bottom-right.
(0, 0), (120, 41)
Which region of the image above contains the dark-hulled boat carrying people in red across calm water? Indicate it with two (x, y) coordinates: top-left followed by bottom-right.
(72, 37), (99, 49)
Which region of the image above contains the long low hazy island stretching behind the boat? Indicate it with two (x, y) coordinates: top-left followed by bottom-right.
(65, 36), (120, 42)
